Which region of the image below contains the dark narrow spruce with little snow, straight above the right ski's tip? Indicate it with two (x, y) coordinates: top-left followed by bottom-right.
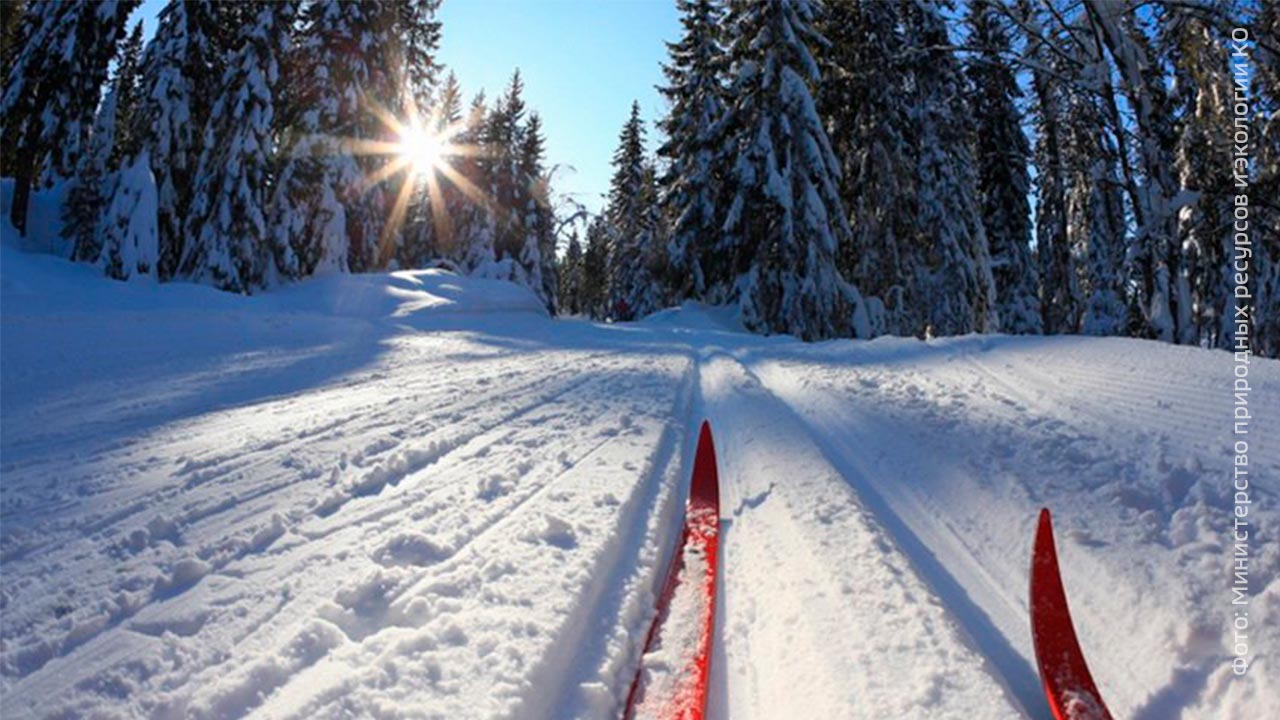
(965, 3), (1042, 334)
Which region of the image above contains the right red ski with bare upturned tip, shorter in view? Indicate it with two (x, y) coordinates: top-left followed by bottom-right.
(1030, 509), (1111, 720)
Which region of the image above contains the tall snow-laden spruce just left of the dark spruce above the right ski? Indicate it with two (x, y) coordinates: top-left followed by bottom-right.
(901, 0), (1000, 334)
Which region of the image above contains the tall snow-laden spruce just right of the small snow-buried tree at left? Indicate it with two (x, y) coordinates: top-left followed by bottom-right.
(179, 1), (298, 292)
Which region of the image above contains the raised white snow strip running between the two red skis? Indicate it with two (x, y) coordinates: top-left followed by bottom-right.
(700, 352), (1021, 720)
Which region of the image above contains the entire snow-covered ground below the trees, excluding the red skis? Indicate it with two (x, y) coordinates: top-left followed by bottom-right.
(0, 243), (1280, 720)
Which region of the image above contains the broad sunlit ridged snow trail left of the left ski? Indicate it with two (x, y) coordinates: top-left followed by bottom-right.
(3, 317), (696, 717)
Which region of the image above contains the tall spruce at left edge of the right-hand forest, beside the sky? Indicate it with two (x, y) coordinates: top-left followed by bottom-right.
(658, 0), (727, 302)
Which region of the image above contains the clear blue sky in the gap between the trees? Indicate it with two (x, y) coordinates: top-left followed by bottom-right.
(137, 0), (680, 210)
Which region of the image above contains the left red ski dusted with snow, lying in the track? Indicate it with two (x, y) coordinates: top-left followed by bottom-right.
(626, 421), (719, 720)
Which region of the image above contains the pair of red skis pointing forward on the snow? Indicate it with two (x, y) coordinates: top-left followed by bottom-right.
(625, 421), (1111, 720)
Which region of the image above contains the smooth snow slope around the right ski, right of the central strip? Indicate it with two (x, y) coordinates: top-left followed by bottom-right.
(748, 338), (1280, 720)
